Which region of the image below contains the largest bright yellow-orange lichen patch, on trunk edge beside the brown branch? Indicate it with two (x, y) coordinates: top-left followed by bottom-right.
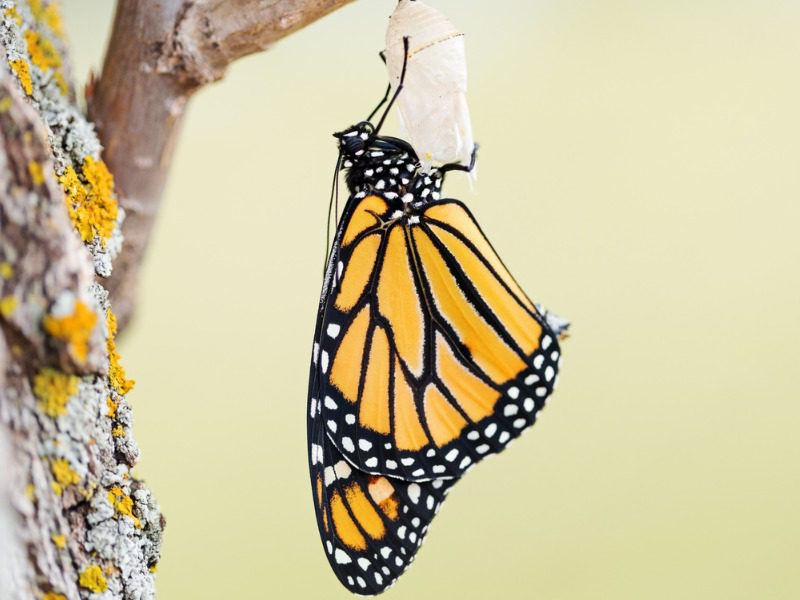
(59, 156), (119, 244)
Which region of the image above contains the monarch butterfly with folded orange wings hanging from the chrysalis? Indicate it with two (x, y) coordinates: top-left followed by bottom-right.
(308, 40), (567, 594)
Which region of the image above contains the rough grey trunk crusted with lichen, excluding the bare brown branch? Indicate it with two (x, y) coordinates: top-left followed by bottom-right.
(0, 0), (163, 600)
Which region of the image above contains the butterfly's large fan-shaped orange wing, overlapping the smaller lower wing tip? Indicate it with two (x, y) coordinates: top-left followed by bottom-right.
(314, 195), (560, 481)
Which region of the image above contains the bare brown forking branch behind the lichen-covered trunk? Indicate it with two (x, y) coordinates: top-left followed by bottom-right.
(89, 0), (351, 327)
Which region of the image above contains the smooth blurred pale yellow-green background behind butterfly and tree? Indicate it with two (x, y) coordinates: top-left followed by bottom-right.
(59, 0), (800, 600)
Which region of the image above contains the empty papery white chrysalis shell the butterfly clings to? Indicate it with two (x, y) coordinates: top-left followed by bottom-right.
(386, 0), (474, 173)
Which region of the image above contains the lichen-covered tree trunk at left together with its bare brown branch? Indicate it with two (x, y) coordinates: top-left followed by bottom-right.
(0, 0), (349, 600)
